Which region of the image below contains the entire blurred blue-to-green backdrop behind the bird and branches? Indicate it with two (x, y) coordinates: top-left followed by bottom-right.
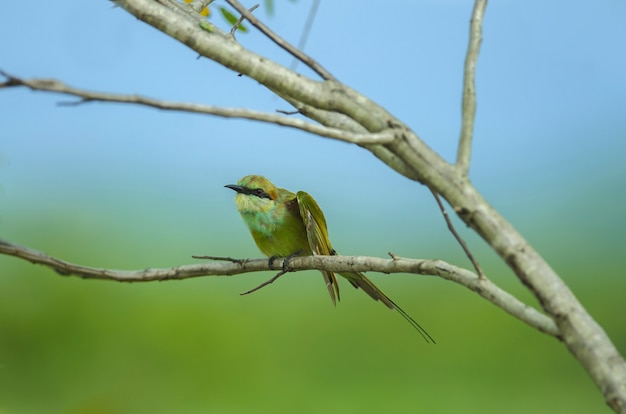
(0, 0), (626, 414)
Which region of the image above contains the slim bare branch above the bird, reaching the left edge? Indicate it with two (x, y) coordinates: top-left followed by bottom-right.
(0, 70), (394, 145)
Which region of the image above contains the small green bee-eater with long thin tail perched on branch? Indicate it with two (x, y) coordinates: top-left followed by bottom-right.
(225, 175), (435, 343)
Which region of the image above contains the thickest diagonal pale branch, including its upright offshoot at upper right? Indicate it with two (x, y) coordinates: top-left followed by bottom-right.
(4, 0), (626, 412)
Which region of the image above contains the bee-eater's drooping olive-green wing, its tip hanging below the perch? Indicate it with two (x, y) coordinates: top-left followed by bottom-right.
(296, 191), (340, 304)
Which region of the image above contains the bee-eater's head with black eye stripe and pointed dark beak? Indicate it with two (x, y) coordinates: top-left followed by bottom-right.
(224, 175), (278, 213)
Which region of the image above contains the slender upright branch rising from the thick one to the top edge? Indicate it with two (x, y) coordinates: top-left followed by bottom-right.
(456, 0), (487, 175)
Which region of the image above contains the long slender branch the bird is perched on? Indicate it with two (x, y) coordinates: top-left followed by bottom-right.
(0, 240), (560, 337)
